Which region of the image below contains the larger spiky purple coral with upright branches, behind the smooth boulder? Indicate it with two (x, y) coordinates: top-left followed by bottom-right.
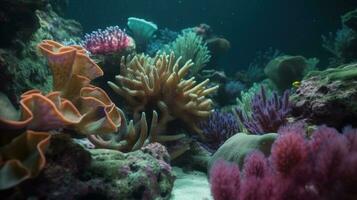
(235, 86), (291, 134)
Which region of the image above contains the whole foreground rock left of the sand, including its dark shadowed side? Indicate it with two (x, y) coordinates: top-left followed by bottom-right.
(1, 134), (175, 199)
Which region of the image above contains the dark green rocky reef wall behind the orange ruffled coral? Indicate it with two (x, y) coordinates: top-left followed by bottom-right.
(0, 0), (81, 101)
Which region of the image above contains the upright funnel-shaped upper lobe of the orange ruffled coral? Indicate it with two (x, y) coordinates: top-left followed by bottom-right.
(38, 40), (103, 101)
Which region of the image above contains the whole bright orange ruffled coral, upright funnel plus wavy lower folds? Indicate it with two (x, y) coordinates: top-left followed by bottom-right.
(0, 40), (121, 134)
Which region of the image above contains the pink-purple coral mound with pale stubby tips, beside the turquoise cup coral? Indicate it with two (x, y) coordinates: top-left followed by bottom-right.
(82, 26), (135, 54)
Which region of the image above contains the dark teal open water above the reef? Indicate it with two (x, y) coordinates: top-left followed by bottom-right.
(67, 0), (357, 69)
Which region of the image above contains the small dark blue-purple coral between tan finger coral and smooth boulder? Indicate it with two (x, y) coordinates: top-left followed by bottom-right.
(198, 111), (239, 152)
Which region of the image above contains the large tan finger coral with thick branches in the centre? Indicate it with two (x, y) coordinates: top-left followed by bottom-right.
(108, 53), (218, 138)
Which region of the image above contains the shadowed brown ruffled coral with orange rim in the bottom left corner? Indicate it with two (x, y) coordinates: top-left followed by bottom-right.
(0, 131), (51, 190)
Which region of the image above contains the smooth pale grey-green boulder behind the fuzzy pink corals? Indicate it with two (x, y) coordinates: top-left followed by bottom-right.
(208, 133), (277, 170)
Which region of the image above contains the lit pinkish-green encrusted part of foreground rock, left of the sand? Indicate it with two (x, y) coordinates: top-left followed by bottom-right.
(89, 144), (175, 199)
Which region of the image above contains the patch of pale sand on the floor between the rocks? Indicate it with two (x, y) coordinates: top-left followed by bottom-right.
(171, 167), (213, 200)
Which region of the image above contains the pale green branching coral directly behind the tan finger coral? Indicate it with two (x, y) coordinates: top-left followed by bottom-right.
(164, 31), (211, 75)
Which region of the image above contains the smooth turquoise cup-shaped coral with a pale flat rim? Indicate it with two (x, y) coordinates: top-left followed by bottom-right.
(127, 17), (157, 49)
